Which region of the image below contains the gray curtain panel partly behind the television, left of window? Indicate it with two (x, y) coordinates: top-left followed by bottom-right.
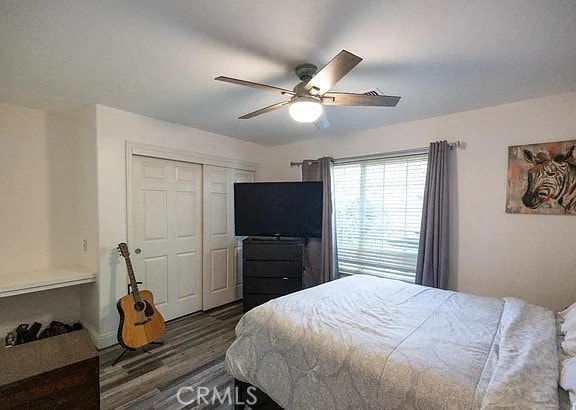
(302, 157), (338, 287)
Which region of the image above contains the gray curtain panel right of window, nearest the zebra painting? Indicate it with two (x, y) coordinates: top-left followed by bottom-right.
(416, 141), (450, 289)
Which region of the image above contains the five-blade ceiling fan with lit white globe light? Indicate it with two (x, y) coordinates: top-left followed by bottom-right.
(215, 50), (400, 128)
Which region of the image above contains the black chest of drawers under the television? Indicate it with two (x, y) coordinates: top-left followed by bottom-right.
(243, 238), (304, 312)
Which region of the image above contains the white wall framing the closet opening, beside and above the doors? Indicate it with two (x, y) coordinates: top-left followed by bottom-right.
(96, 105), (266, 347)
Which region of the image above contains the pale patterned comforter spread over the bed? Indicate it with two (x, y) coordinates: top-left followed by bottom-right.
(226, 275), (559, 409)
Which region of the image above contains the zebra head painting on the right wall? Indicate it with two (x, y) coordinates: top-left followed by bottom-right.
(506, 140), (576, 215)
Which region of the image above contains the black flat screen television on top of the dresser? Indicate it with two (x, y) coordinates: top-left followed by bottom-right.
(234, 182), (323, 238)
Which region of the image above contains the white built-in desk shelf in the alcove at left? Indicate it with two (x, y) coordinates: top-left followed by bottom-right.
(0, 266), (96, 298)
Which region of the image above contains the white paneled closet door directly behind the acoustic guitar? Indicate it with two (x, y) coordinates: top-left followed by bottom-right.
(128, 156), (202, 320)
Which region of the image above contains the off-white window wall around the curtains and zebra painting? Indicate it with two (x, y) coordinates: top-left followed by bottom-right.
(260, 93), (576, 309)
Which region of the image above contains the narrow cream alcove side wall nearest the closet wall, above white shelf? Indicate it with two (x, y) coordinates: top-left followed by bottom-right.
(47, 108), (98, 272)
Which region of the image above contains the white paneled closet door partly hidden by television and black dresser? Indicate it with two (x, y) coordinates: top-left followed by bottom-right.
(202, 165), (254, 310)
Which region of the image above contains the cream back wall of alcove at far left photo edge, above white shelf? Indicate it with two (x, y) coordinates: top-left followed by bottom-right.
(0, 104), (50, 274)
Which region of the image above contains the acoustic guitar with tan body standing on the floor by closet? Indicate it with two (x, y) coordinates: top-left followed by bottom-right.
(116, 243), (164, 349)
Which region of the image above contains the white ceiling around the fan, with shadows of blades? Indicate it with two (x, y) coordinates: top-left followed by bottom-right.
(0, 0), (576, 145)
